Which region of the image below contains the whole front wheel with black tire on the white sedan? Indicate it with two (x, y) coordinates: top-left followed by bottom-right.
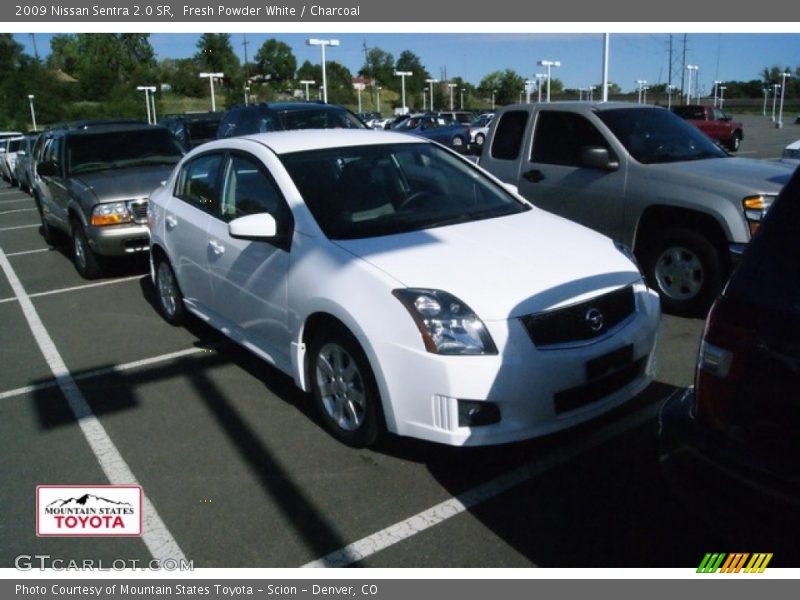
(309, 327), (385, 448)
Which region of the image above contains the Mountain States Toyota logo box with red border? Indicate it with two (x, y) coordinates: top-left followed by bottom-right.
(36, 485), (142, 537)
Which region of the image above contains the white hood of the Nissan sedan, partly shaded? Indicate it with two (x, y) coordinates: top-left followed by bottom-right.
(334, 209), (641, 321)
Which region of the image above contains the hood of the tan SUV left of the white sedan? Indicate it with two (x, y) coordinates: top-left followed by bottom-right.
(69, 165), (173, 202)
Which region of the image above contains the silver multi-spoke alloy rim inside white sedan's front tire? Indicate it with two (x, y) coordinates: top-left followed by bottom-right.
(314, 342), (367, 431)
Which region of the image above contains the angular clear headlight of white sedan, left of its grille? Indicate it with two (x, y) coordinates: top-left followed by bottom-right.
(392, 288), (497, 355)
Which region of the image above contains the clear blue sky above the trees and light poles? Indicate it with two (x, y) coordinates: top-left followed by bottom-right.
(14, 31), (800, 92)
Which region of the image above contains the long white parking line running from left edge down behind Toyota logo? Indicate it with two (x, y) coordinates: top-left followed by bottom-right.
(0, 249), (186, 561)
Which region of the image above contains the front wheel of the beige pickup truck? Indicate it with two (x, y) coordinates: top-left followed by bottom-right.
(643, 228), (723, 317)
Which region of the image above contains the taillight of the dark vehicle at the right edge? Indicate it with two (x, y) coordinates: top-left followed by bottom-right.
(695, 297), (756, 429)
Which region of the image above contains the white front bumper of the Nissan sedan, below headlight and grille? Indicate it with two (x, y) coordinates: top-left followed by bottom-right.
(376, 284), (661, 446)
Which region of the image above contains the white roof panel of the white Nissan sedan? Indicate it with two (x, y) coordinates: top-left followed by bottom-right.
(202, 129), (430, 154)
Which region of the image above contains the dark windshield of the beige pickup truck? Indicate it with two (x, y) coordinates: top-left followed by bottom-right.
(597, 107), (728, 165)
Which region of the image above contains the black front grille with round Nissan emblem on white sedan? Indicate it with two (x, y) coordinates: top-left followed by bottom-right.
(520, 286), (636, 346)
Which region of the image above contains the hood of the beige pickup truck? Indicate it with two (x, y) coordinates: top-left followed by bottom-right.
(647, 157), (792, 194)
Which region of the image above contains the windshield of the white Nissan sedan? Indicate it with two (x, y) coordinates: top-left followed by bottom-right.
(281, 143), (530, 239)
